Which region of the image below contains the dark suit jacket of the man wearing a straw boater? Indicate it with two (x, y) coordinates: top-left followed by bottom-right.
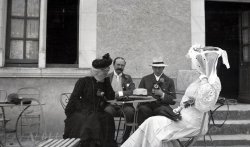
(139, 74), (176, 105)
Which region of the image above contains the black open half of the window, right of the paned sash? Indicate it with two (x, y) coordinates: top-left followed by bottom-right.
(46, 0), (79, 66)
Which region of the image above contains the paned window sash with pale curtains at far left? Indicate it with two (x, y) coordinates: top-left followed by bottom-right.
(6, 0), (40, 66)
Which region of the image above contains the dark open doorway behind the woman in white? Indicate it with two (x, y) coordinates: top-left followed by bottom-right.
(205, 1), (242, 99)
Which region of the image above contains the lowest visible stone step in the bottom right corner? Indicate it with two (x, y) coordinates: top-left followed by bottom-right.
(194, 134), (250, 146)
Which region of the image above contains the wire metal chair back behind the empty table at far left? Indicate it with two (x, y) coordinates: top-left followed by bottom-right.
(16, 87), (46, 138)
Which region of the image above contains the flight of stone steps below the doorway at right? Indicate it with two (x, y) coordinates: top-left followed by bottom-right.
(194, 104), (250, 147)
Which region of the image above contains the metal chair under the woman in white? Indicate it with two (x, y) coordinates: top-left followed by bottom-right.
(162, 112), (209, 147)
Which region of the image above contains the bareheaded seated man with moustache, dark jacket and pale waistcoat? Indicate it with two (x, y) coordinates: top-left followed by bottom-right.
(105, 57), (135, 142)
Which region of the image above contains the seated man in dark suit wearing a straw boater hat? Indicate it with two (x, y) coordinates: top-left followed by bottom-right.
(138, 57), (176, 125)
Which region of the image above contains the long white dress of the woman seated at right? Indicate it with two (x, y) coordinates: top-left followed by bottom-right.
(121, 46), (230, 147)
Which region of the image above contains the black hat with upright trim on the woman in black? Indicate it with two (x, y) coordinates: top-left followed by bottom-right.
(92, 53), (112, 69)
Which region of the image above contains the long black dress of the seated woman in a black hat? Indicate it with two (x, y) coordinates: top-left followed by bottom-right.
(63, 77), (117, 147)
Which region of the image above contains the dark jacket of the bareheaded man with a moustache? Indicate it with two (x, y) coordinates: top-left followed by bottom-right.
(108, 72), (135, 96)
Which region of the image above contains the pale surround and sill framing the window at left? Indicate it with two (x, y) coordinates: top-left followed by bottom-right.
(0, 0), (97, 78)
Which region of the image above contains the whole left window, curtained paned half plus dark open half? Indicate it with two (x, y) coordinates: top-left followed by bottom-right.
(6, 0), (79, 67)
